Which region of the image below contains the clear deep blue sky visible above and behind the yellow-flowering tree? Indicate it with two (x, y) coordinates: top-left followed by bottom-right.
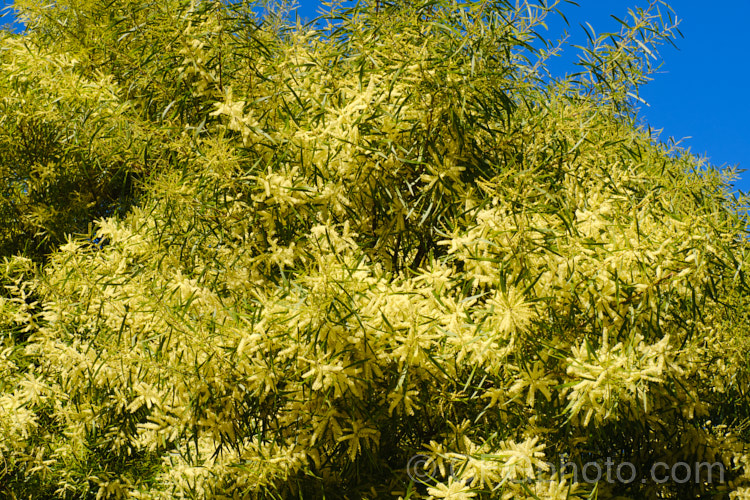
(0, 0), (750, 192)
